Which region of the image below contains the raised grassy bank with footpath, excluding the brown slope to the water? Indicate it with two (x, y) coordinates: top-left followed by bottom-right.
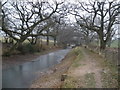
(61, 47), (118, 88)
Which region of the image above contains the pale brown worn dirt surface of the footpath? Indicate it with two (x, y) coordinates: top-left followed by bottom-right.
(65, 49), (103, 88)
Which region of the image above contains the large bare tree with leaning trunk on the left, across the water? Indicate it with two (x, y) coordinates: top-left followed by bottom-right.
(2, 1), (62, 50)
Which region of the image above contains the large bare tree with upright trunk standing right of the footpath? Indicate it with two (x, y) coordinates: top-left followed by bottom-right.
(69, 1), (120, 50)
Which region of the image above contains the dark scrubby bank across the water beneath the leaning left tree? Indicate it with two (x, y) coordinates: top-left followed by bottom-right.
(2, 40), (60, 56)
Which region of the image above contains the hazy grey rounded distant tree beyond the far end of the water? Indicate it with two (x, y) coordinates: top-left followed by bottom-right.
(57, 25), (81, 47)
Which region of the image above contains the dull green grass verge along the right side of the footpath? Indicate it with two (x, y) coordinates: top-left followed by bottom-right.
(88, 47), (119, 88)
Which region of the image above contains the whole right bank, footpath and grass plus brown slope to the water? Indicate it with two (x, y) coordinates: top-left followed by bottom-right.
(31, 48), (118, 88)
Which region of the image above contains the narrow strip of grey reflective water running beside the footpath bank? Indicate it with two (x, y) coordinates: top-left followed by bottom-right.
(2, 49), (70, 88)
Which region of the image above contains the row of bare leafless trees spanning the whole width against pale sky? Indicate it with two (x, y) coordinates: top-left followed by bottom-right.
(1, 0), (120, 52)
